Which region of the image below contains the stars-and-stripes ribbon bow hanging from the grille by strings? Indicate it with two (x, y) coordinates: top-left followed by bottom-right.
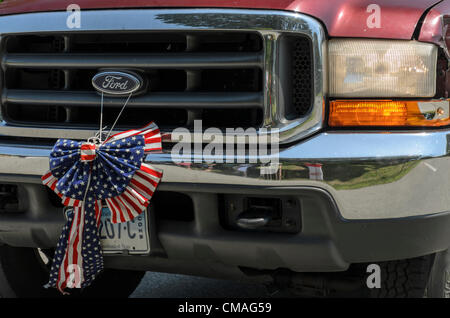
(42, 122), (162, 293)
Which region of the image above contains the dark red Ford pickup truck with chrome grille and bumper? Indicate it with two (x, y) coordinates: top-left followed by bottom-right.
(0, 0), (450, 297)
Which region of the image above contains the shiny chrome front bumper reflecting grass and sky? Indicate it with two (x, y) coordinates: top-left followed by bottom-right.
(0, 131), (450, 219)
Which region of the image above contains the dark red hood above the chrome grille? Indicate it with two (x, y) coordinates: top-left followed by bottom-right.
(0, 0), (447, 39)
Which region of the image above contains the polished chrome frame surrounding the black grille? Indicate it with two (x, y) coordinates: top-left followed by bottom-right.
(0, 9), (327, 143)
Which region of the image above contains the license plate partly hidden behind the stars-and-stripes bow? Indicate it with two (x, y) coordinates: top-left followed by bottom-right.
(99, 208), (150, 254)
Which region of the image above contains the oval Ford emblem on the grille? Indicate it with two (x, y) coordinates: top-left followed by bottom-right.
(92, 71), (142, 95)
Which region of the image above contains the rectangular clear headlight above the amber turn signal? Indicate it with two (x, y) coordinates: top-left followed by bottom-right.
(328, 39), (437, 98)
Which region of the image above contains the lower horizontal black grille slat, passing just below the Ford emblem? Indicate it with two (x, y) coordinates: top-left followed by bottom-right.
(2, 89), (263, 109)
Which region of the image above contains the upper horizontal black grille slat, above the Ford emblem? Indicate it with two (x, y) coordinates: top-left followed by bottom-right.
(2, 52), (263, 69)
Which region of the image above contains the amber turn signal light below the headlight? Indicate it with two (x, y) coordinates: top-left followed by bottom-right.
(328, 100), (450, 127)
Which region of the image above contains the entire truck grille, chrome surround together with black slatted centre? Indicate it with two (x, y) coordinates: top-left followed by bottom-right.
(0, 9), (326, 143)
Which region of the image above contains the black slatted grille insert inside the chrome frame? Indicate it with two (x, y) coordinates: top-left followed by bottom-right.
(2, 32), (263, 129)
